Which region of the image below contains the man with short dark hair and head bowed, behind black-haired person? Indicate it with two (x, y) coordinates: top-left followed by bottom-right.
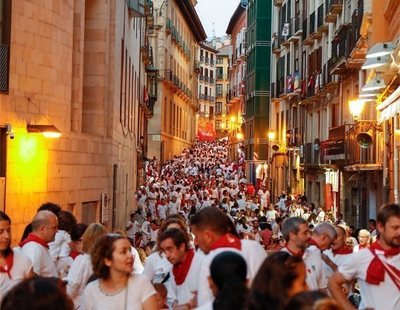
(191, 207), (267, 306)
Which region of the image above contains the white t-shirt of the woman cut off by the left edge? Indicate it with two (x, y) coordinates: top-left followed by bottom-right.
(0, 251), (32, 302)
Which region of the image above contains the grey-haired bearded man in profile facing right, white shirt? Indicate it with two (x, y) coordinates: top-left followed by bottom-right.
(282, 217), (328, 290)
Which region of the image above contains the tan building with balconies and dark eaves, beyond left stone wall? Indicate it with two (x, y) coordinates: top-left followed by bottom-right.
(147, 0), (206, 162)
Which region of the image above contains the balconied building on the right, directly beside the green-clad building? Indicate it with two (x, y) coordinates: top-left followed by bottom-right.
(271, 0), (384, 227)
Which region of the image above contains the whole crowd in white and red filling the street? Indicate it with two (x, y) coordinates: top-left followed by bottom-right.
(0, 140), (400, 310)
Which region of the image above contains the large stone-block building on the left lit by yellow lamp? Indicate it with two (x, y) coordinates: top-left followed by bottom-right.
(0, 0), (153, 241)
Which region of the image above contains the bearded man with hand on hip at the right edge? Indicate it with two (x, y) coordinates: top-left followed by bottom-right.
(329, 204), (400, 310)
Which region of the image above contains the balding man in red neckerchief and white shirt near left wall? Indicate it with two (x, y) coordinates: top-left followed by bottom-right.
(20, 211), (58, 277)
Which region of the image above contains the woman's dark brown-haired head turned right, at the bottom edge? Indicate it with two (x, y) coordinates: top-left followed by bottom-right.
(247, 252), (308, 310)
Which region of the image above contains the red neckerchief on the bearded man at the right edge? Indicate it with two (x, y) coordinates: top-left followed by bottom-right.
(365, 242), (400, 285)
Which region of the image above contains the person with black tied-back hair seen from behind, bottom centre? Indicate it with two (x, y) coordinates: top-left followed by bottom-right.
(198, 251), (248, 310)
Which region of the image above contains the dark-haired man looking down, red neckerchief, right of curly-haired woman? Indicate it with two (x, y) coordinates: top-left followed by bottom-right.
(158, 228), (203, 308)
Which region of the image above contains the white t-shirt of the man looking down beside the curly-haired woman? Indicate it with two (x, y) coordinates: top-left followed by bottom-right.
(167, 253), (204, 306)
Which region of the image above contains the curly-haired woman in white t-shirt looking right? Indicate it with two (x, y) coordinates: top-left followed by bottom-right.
(81, 234), (158, 310)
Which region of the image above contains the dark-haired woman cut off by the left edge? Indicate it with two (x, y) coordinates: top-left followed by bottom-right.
(0, 211), (33, 299)
